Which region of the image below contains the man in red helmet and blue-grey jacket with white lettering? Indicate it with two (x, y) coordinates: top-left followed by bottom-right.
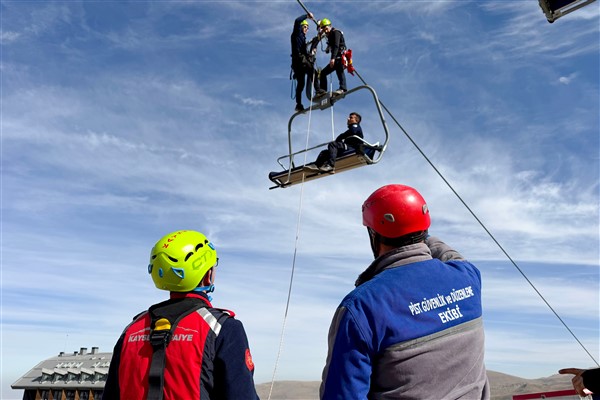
(320, 184), (490, 400)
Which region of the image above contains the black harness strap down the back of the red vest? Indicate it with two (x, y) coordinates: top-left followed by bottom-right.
(146, 303), (206, 400)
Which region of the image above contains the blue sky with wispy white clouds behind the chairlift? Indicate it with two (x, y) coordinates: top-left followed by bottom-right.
(0, 1), (600, 399)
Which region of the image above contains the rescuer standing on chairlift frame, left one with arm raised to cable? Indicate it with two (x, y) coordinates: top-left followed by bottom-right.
(290, 13), (316, 111)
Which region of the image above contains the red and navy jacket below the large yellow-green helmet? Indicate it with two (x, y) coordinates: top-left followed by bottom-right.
(103, 293), (258, 400)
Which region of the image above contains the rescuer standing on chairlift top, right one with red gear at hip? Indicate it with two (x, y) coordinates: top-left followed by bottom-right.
(317, 18), (348, 96)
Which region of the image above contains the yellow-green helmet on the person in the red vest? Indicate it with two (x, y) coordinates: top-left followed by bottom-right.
(148, 231), (217, 292)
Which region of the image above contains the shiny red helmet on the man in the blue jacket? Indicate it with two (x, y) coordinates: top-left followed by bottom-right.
(362, 185), (431, 238)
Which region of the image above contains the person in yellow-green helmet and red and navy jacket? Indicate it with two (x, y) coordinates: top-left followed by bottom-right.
(103, 230), (258, 400)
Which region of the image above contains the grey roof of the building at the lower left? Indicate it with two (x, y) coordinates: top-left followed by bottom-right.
(11, 347), (112, 389)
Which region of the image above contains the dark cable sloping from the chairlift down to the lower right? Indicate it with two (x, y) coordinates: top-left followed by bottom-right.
(354, 69), (600, 367)
